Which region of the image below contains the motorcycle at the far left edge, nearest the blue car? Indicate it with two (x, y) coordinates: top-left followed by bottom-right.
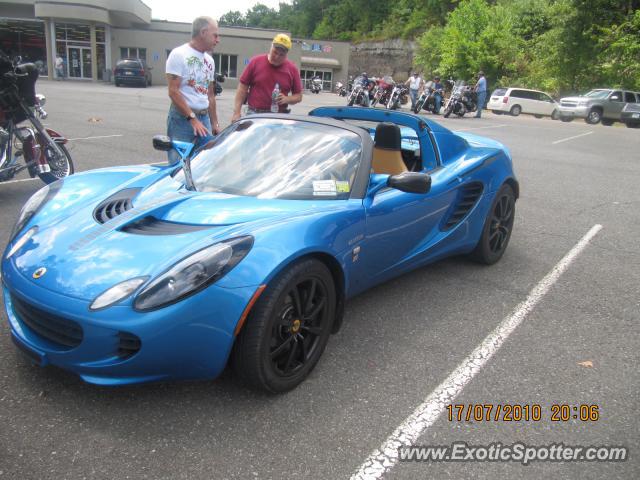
(0, 52), (74, 183)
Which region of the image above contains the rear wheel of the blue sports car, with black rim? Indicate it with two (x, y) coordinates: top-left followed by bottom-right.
(471, 183), (516, 265)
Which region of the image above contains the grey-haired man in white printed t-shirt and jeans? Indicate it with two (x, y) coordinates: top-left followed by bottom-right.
(166, 17), (220, 163)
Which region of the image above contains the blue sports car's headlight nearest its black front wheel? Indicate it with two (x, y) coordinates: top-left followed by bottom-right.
(133, 236), (253, 311)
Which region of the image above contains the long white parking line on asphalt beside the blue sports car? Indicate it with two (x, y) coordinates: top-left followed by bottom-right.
(351, 225), (602, 480)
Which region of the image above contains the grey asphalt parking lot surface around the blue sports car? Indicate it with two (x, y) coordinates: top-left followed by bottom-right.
(0, 81), (640, 480)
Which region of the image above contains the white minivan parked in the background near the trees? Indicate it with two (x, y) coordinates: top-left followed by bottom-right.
(487, 88), (559, 120)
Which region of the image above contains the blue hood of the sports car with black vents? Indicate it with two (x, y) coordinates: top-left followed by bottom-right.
(11, 172), (337, 300)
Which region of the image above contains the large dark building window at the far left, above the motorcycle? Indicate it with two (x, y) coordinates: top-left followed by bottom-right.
(0, 18), (48, 75)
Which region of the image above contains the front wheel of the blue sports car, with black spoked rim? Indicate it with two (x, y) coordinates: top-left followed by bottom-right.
(232, 259), (336, 393)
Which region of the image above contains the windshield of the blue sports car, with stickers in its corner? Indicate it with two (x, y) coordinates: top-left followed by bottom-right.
(176, 118), (362, 200)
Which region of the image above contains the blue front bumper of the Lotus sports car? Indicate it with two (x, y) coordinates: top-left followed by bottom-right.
(3, 255), (257, 385)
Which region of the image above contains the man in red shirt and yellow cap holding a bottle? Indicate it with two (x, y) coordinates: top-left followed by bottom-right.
(231, 33), (302, 123)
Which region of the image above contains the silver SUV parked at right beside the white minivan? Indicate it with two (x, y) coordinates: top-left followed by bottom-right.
(559, 88), (640, 125)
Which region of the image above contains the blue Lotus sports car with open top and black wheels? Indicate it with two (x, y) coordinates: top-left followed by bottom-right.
(2, 107), (519, 392)
